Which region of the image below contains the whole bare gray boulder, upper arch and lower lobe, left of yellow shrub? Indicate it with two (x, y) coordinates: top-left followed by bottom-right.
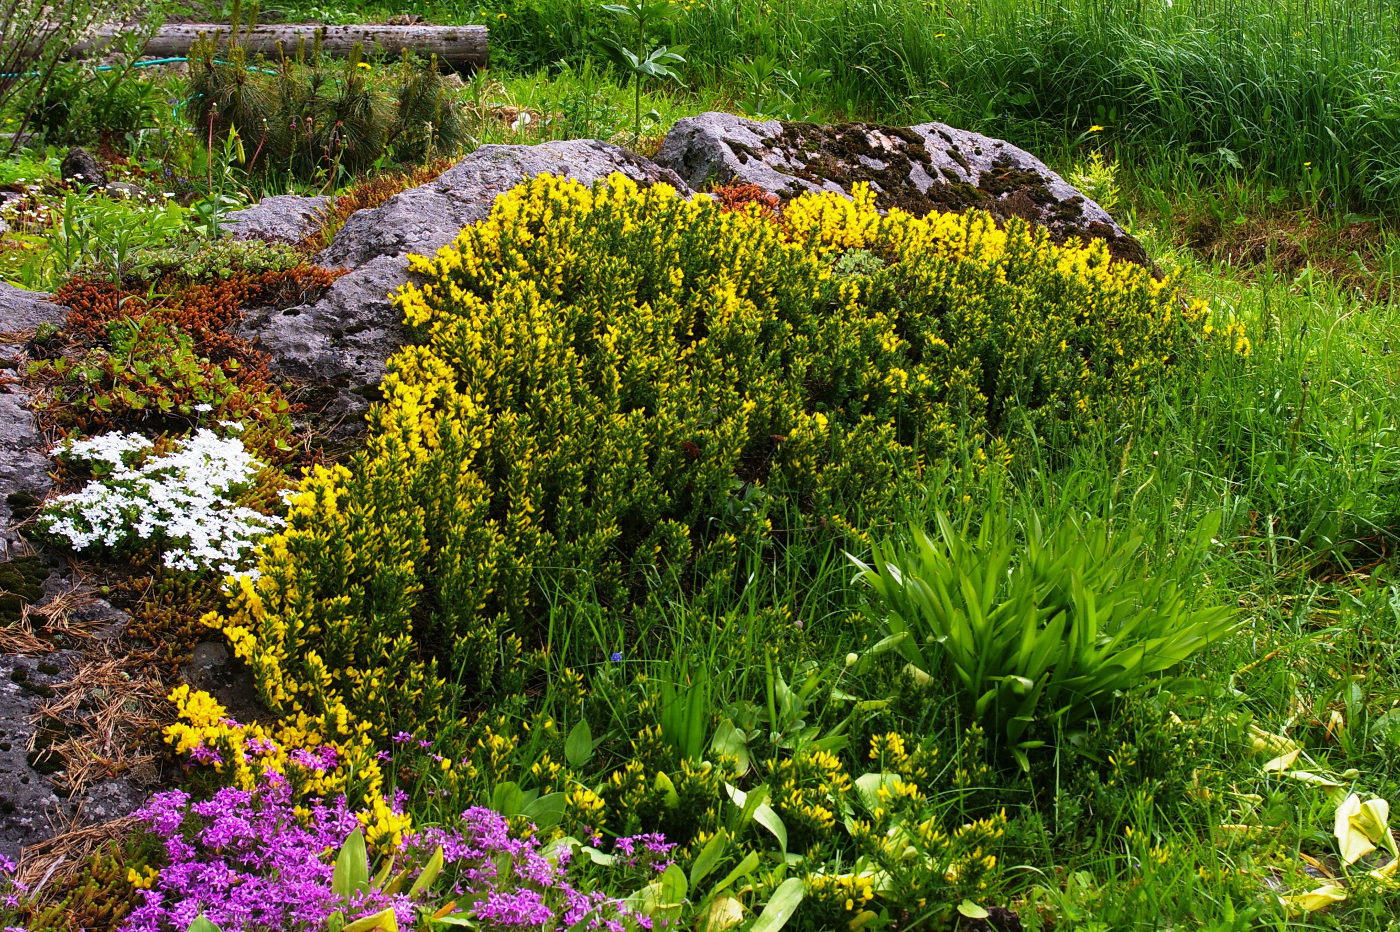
(249, 140), (686, 439)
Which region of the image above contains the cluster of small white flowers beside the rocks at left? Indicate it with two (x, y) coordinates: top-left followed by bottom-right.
(42, 430), (283, 574)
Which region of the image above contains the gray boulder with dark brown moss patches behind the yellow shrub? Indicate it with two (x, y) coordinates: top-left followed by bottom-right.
(657, 113), (1148, 264)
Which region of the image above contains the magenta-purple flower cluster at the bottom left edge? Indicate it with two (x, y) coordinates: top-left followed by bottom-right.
(122, 774), (671, 932)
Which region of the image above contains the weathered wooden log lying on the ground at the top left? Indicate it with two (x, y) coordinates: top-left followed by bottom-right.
(69, 22), (486, 71)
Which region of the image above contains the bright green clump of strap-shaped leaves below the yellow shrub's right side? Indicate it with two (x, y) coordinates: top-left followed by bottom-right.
(855, 515), (1235, 765)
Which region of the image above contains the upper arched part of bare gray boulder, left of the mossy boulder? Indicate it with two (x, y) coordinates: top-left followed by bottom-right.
(316, 139), (685, 269)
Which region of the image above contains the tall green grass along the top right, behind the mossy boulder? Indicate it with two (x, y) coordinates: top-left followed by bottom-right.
(478, 0), (1400, 207)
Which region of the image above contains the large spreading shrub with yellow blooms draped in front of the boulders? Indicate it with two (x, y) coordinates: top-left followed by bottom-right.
(204, 176), (1226, 750)
